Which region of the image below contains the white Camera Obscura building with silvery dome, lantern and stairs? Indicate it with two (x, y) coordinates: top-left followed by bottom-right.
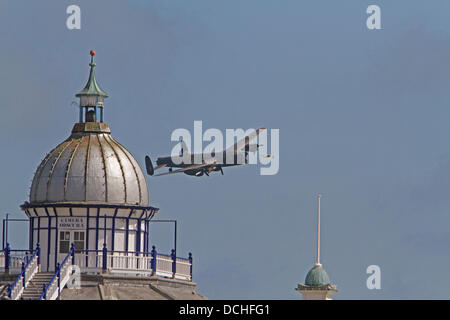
(0, 51), (203, 299)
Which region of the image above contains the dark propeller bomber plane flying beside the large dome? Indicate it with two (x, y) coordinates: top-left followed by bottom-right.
(145, 128), (270, 177)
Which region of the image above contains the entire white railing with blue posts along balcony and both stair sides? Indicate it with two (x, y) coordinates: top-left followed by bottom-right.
(0, 244), (192, 300)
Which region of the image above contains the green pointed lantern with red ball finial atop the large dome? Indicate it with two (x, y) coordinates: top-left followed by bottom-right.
(75, 50), (108, 122)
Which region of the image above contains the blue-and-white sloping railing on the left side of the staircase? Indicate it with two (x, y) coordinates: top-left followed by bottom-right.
(8, 244), (41, 300)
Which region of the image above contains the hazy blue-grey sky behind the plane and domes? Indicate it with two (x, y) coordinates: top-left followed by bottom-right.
(0, 0), (450, 299)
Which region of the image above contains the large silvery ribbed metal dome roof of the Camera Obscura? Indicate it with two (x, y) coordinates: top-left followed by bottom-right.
(30, 122), (149, 206)
